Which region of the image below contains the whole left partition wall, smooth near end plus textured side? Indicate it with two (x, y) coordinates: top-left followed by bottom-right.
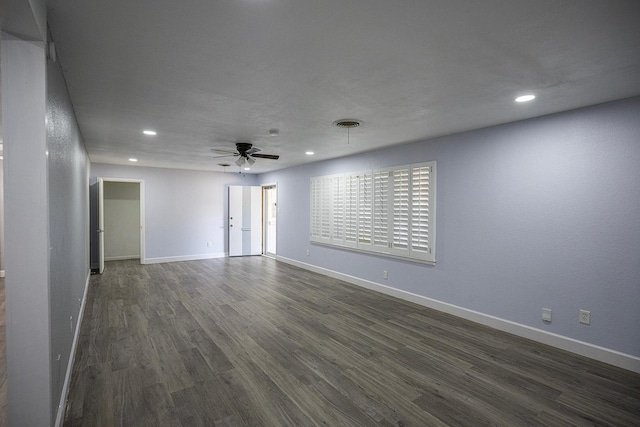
(0, 0), (89, 426)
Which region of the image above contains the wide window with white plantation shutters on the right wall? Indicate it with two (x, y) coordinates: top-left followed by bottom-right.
(309, 162), (436, 263)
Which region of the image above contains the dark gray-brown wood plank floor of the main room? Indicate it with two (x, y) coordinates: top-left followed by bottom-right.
(65, 257), (640, 426)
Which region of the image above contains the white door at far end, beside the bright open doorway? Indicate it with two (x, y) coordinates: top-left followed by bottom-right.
(229, 185), (262, 256)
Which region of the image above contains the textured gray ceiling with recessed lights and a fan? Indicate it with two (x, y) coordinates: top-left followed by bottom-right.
(47, 0), (640, 173)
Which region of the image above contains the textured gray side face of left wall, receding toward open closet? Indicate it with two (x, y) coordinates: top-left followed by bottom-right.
(47, 45), (89, 422)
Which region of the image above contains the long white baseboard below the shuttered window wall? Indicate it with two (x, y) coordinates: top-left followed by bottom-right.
(276, 255), (640, 373)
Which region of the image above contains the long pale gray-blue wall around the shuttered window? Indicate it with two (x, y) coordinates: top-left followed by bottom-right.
(260, 98), (640, 356)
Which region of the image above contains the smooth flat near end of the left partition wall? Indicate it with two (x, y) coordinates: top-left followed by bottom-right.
(1, 33), (52, 426)
